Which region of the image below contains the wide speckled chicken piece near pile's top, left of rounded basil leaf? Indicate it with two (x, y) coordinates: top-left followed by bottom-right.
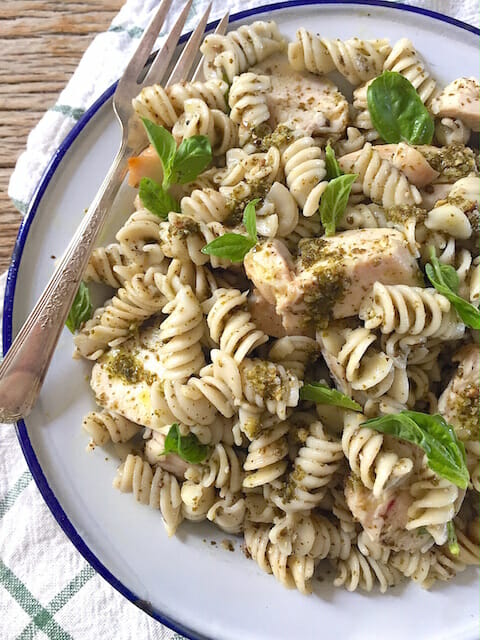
(252, 54), (348, 138)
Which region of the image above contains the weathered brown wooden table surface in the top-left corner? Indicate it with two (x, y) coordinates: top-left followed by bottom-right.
(0, 0), (124, 273)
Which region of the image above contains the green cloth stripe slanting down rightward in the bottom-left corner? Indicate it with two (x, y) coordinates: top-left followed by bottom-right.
(0, 559), (73, 640)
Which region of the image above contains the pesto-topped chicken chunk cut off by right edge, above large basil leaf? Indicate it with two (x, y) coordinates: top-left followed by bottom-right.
(438, 344), (480, 440)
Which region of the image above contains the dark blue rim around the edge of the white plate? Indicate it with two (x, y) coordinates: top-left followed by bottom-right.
(3, 0), (480, 640)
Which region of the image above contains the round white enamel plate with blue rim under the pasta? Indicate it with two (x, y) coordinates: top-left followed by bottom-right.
(5, 3), (478, 640)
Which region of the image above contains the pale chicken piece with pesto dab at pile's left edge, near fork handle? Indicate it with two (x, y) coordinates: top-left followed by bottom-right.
(90, 326), (173, 429)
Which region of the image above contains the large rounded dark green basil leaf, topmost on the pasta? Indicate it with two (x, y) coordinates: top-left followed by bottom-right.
(367, 71), (435, 144)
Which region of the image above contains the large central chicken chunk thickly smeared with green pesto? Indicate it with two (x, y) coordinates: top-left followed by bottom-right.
(277, 229), (421, 328)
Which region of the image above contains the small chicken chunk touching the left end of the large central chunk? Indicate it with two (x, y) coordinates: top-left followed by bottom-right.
(243, 240), (295, 305)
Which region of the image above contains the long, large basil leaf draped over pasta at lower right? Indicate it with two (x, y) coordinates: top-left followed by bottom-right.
(361, 411), (470, 489)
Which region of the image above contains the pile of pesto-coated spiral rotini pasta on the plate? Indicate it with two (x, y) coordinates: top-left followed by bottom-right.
(75, 22), (480, 593)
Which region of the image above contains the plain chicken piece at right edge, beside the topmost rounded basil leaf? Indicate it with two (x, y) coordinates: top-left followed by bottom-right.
(431, 78), (480, 131)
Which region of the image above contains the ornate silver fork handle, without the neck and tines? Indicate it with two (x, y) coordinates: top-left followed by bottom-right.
(0, 141), (131, 423)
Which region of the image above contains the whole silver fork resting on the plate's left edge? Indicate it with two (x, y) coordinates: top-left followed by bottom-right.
(0, 0), (228, 422)
